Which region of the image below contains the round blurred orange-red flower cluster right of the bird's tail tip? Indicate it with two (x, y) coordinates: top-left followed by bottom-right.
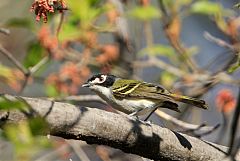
(216, 89), (236, 113)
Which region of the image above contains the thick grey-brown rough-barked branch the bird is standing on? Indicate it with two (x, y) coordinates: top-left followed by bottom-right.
(0, 96), (240, 161)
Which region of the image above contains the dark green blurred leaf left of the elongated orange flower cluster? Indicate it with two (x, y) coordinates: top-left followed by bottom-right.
(23, 42), (44, 68)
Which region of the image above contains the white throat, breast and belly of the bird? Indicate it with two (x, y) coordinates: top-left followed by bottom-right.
(90, 85), (156, 115)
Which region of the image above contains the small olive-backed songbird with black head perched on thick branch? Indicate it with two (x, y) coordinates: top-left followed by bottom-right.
(82, 74), (208, 116)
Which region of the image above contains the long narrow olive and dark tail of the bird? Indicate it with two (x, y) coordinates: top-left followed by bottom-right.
(169, 93), (208, 109)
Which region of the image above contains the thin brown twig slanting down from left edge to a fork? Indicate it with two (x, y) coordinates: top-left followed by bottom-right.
(0, 44), (29, 75)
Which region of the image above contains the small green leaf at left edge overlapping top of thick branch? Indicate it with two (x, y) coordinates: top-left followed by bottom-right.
(0, 97), (26, 110)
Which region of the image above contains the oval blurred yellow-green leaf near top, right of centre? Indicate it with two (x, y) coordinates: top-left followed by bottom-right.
(128, 6), (161, 21)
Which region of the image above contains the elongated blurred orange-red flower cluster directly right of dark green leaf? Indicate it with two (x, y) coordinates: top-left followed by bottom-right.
(38, 25), (63, 60)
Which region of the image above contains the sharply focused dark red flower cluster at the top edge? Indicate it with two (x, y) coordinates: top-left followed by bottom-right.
(30, 0), (67, 23)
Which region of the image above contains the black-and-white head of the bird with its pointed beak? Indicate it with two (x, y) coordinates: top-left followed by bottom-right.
(82, 74), (116, 89)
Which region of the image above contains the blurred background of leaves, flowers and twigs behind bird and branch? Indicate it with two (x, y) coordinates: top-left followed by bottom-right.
(0, 0), (240, 161)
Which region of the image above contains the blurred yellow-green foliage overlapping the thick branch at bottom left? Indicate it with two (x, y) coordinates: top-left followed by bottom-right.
(0, 96), (51, 160)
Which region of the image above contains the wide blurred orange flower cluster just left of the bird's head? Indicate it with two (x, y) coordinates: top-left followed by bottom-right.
(46, 62), (90, 94)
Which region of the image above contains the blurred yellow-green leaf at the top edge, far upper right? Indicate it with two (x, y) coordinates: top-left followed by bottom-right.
(190, 1), (233, 16)
